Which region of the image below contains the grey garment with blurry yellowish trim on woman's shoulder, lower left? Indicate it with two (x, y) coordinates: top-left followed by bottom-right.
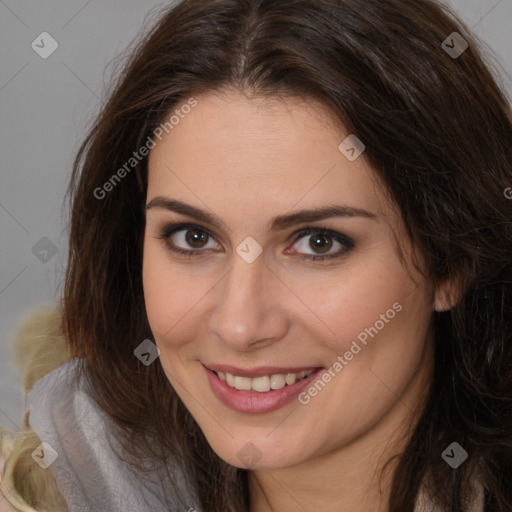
(4, 306), (200, 512)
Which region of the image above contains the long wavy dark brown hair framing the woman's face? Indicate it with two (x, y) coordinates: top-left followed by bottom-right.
(61, 0), (512, 512)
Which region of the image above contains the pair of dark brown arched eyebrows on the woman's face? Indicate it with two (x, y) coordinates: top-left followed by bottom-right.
(146, 196), (378, 231)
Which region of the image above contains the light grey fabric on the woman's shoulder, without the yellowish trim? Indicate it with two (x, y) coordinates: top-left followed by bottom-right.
(27, 358), (200, 512)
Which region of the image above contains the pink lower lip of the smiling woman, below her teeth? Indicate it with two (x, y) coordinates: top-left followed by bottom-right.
(205, 368), (323, 414)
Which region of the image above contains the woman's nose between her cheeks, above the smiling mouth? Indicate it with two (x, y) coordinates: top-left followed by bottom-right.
(208, 253), (290, 351)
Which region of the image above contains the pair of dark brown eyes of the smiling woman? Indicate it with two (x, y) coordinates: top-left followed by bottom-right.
(158, 224), (354, 261)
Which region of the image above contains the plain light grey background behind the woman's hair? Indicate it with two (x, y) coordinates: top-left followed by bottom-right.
(0, 0), (512, 431)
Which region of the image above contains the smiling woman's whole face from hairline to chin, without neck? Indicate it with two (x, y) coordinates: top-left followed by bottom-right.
(143, 91), (436, 469)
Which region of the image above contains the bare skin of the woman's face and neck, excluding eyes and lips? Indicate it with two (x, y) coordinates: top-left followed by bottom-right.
(143, 89), (454, 512)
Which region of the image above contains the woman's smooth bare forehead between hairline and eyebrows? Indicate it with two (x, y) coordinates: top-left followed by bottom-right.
(148, 90), (390, 220)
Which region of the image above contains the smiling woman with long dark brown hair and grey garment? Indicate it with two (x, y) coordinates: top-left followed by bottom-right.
(4, 0), (512, 512)
